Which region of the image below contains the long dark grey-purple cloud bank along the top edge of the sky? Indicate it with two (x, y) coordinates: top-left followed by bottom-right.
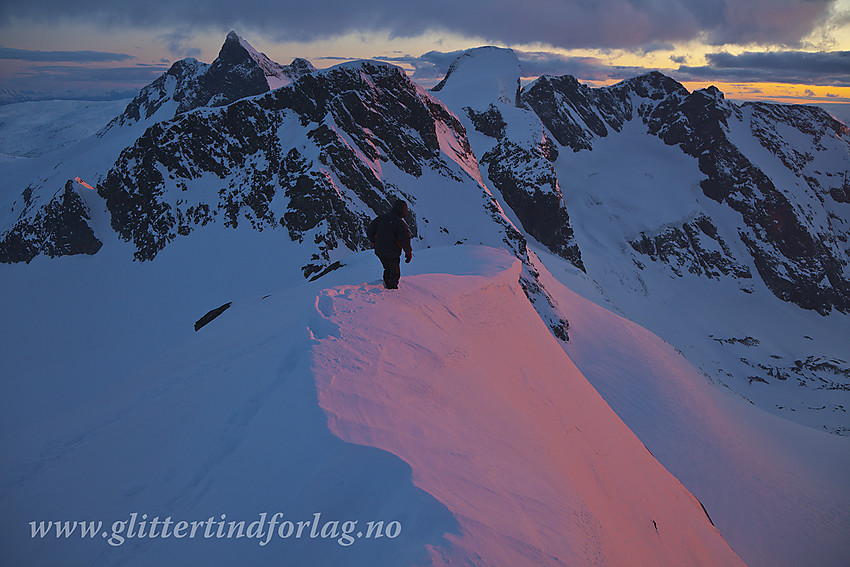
(0, 0), (836, 48)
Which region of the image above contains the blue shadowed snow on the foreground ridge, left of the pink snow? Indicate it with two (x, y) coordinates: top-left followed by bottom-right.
(0, 247), (464, 567)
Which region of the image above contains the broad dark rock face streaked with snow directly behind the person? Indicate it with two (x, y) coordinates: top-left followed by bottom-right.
(99, 62), (474, 277)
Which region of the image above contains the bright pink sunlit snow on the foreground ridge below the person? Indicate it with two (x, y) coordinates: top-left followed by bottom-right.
(314, 249), (743, 566)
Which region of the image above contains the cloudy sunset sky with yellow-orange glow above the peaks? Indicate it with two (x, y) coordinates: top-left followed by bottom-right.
(0, 0), (850, 108)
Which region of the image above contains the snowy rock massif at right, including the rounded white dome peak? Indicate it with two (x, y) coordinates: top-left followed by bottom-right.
(436, 48), (850, 433)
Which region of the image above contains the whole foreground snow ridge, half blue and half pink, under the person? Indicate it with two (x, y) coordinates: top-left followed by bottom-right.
(0, 247), (741, 566)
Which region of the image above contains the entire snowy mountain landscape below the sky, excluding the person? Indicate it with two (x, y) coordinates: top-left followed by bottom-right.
(0, 33), (850, 566)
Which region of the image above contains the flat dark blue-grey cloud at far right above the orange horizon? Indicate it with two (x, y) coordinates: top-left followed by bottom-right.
(677, 51), (850, 87)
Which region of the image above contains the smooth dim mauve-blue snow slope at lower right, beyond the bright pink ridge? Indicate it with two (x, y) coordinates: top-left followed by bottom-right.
(528, 252), (850, 567)
